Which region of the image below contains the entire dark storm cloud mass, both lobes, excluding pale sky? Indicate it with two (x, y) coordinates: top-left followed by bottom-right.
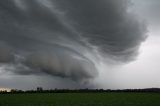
(0, 0), (146, 81)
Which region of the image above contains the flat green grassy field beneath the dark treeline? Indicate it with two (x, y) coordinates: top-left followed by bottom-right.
(0, 93), (160, 106)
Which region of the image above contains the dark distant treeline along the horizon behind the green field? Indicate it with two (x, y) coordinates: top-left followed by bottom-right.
(0, 87), (160, 94)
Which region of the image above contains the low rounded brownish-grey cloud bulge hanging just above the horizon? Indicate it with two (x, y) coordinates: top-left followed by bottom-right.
(26, 52), (97, 80)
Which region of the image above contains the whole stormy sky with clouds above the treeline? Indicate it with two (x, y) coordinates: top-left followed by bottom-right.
(0, 0), (160, 90)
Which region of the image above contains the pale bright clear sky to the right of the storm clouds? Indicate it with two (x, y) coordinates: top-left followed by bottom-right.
(97, 0), (160, 89)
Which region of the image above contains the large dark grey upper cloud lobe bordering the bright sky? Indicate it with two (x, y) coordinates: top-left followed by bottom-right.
(54, 0), (146, 59)
